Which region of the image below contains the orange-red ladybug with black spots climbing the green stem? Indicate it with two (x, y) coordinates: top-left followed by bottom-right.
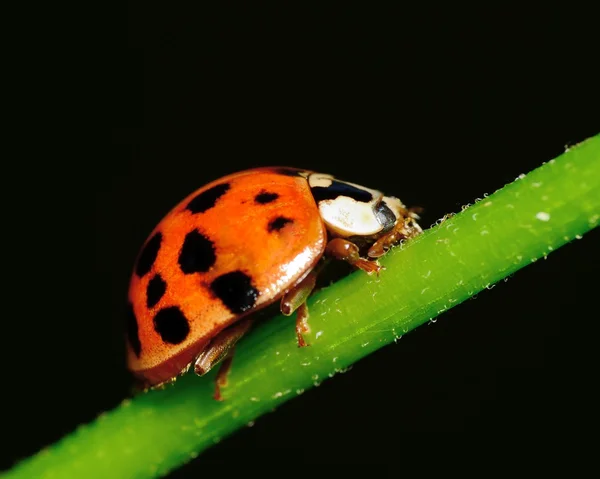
(127, 167), (422, 400)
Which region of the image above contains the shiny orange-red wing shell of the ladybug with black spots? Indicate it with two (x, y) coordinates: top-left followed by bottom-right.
(127, 168), (327, 386)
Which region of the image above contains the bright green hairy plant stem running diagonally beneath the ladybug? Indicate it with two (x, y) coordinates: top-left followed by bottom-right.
(6, 135), (600, 479)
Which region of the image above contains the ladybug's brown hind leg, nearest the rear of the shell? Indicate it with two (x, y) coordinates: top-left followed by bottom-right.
(194, 319), (252, 401)
